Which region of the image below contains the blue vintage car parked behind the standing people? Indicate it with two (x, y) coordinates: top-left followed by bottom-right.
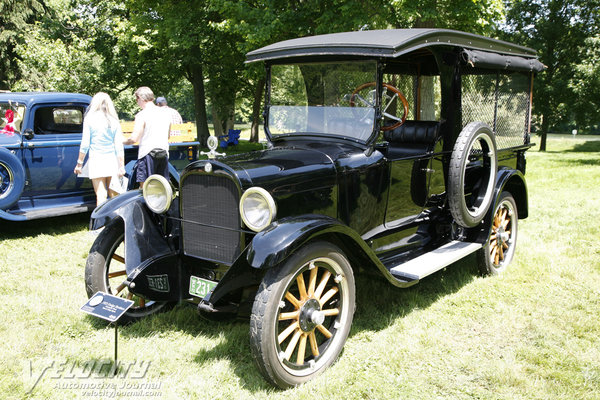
(0, 93), (197, 221)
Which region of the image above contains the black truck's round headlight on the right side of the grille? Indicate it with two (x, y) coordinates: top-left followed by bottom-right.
(240, 187), (277, 232)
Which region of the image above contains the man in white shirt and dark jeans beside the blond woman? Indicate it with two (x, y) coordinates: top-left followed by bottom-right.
(123, 86), (171, 187)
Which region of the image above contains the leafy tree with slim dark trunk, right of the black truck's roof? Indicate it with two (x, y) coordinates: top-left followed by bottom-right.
(505, 0), (600, 151)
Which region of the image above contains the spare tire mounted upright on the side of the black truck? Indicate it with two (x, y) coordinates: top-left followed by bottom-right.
(448, 122), (498, 228)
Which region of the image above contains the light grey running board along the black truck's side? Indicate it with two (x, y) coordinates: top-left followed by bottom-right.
(390, 240), (483, 283)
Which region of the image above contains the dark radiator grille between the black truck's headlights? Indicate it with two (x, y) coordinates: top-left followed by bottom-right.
(181, 174), (241, 264)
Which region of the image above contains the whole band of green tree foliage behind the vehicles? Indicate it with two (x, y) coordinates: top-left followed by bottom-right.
(8, 0), (600, 148)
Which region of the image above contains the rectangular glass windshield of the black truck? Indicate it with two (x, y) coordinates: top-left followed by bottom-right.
(267, 62), (377, 142)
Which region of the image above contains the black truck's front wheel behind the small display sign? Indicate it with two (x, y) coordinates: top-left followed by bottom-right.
(85, 219), (172, 323)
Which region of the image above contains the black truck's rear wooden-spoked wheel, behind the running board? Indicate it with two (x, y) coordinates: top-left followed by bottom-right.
(477, 192), (519, 275)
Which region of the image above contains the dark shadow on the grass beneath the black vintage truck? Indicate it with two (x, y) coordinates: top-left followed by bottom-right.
(99, 256), (477, 393)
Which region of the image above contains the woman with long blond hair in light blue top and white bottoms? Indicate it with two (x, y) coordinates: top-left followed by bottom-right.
(73, 92), (125, 205)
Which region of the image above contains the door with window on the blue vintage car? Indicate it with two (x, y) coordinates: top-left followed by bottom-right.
(22, 103), (93, 201)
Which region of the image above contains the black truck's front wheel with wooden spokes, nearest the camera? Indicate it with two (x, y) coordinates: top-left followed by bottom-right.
(250, 242), (355, 388)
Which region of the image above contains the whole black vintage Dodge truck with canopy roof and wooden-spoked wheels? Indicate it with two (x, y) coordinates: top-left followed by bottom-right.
(85, 29), (543, 388)
